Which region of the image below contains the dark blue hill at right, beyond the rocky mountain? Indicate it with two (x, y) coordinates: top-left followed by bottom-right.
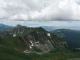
(53, 29), (80, 48)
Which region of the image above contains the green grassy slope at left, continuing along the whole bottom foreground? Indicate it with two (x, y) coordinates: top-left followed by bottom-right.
(0, 28), (80, 60)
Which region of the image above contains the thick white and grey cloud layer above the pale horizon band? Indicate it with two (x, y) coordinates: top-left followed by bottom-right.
(0, 0), (80, 20)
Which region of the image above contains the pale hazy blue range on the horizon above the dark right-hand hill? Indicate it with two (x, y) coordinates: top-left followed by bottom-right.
(42, 26), (80, 32)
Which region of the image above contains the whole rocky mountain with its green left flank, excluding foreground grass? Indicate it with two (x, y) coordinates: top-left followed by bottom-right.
(0, 25), (67, 53)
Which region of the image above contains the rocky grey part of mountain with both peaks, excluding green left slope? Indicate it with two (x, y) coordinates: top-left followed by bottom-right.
(0, 26), (67, 52)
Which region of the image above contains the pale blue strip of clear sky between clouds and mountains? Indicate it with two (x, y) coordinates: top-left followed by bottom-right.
(0, 21), (80, 30)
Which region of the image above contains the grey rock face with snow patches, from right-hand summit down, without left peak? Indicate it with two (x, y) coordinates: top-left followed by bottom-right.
(12, 27), (66, 52)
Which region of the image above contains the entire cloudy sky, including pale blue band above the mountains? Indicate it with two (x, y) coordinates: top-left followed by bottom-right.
(0, 0), (80, 28)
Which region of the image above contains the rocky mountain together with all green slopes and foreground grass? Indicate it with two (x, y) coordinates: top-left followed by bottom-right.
(0, 25), (80, 60)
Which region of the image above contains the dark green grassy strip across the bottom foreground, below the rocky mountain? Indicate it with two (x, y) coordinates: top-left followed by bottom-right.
(0, 47), (80, 60)
